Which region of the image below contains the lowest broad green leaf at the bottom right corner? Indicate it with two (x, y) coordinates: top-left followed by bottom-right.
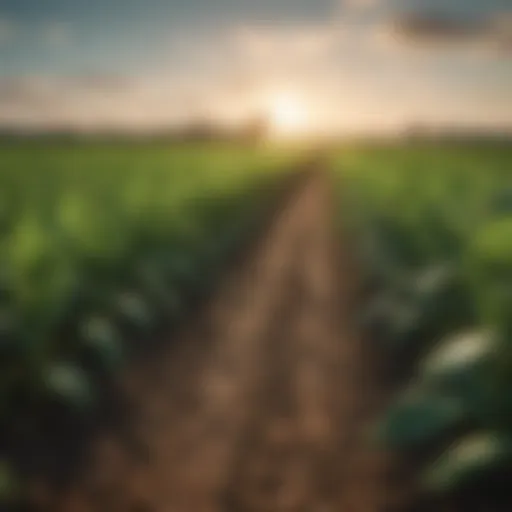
(422, 432), (512, 493)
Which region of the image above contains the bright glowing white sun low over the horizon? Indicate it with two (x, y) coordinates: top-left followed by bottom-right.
(269, 93), (309, 136)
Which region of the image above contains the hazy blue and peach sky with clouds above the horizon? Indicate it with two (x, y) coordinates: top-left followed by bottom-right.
(0, 0), (512, 133)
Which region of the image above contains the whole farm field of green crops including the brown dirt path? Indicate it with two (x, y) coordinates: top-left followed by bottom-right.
(0, 144), (512, 512)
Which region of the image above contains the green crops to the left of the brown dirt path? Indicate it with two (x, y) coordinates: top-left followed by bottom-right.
(0, 143), (296, 497)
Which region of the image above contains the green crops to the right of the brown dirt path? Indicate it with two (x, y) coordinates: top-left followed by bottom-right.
(336, 145), (512, 504)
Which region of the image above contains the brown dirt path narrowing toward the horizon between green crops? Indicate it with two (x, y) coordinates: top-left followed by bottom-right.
(51, 169), (412, 512)
